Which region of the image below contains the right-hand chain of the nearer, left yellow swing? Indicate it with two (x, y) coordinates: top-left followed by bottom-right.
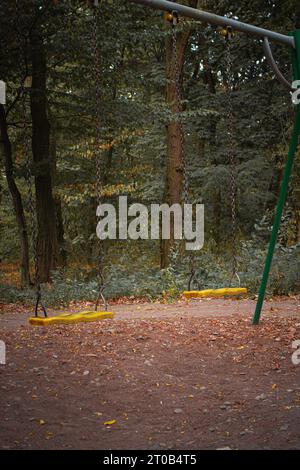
(92, 2), (107, 311)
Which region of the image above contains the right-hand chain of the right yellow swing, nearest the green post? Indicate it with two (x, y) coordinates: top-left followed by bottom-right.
(225, 27), (240, 284)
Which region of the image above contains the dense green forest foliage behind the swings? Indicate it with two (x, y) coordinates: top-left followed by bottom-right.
(0, 0), (300, 305)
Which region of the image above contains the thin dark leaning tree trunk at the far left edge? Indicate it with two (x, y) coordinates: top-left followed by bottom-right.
(0, 104), (30, 287)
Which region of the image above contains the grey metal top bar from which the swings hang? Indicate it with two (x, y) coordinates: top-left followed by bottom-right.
(129, 0), (295, 48)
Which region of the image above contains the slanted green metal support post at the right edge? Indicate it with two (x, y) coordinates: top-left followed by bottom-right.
(253, 30), (300, 325)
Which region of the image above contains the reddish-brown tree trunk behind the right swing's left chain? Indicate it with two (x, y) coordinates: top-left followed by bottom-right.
(161, 0), (197, 268)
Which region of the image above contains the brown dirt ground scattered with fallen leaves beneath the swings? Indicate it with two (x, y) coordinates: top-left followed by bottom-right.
(0, 297), (300, 450)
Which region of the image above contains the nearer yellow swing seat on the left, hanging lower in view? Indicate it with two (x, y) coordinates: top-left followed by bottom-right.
(29, 310), (114, 326)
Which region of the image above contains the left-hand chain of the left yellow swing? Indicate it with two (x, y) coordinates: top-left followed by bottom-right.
(15, 0), (47, 318)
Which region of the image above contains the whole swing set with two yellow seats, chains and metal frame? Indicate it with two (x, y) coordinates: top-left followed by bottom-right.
(16, 0), (300, 325)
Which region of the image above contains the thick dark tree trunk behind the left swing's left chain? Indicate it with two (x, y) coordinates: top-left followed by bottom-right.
(30, 29), (59, 282)
